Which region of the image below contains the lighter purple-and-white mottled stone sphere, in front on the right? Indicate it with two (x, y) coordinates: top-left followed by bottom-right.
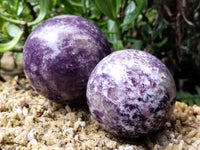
(87, 50), (176, 137)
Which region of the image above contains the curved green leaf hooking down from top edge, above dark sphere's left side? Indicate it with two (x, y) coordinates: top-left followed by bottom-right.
(28, 0), (51, 26)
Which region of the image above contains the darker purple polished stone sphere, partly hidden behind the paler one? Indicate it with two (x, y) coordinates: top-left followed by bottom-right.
(23, 15), (111, 103)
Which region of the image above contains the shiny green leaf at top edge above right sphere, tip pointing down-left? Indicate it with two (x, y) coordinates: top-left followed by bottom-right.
(121, 0), (147, 27)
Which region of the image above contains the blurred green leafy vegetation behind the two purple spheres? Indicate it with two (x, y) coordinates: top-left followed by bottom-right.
(0, 0), (200, 105)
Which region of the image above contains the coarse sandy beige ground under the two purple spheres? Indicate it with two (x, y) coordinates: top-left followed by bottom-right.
(0, 77), (200, 150)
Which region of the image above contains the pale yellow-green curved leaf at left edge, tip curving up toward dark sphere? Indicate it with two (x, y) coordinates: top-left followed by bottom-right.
(0, 31), (23, 53)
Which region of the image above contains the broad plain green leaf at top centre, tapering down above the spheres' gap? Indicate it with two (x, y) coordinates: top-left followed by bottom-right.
(94, 0), (121, 20)
